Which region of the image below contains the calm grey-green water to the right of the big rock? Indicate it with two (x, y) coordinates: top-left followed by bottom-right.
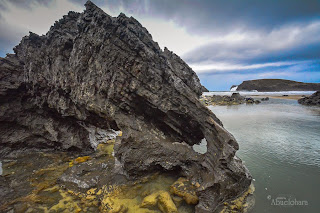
(210, 99), (320, 213)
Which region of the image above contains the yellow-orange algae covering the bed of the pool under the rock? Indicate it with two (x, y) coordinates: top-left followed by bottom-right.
(0, 132), (194, 213)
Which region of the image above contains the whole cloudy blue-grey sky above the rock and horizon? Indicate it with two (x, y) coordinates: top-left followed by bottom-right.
(0, 0), (320, 90)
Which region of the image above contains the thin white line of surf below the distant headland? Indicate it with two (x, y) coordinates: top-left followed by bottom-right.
(202, 88), (316, 96)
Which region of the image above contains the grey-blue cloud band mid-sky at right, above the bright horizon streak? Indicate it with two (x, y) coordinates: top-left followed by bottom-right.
(184, 20), (320, 64)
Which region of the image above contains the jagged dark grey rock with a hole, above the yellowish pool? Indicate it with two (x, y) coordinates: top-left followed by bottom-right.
(0, 1), (251, 212)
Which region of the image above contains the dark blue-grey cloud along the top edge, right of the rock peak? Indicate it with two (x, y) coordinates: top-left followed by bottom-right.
(83, 0), (320, 34)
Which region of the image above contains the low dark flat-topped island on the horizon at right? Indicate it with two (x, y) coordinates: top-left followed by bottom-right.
(230, 79), (320, 92)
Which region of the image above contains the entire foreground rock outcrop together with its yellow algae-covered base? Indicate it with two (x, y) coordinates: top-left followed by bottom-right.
(0, 1), (252, 213)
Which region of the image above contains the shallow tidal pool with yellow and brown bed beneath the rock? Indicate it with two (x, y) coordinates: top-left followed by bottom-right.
(0, 138), (199, 213)
